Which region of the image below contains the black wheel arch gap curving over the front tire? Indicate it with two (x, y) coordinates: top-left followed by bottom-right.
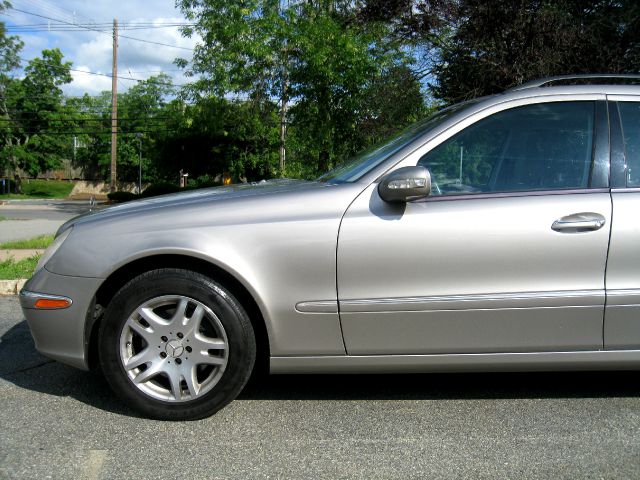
(85, 254), (270, 373)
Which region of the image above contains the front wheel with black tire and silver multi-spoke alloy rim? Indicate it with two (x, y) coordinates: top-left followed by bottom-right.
(99, 268), (256, 420)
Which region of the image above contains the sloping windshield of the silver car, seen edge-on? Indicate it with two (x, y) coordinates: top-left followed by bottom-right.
(318, 100), (477, 183)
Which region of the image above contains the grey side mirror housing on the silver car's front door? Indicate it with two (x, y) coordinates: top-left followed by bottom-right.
(378, 166), (431, 202)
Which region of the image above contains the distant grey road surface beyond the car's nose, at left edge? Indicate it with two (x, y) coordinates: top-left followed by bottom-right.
(0, 200), (96, 243)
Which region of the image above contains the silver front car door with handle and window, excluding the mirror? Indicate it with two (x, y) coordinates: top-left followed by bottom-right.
(337, 96), (611, 355)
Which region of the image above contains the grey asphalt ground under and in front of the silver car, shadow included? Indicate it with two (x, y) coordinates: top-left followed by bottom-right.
(0, 297), (640, 480)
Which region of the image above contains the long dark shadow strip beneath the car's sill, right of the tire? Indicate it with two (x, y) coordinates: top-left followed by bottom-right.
(240, 371), (640, 400)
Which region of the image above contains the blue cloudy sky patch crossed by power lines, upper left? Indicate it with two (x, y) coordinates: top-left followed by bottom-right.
(0, 0), (196, 96)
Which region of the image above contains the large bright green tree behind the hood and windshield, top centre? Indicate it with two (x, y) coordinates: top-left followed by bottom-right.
(178, 0), (423, 176)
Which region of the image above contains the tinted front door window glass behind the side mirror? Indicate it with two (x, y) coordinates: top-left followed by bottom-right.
(418, 102), (596, 195)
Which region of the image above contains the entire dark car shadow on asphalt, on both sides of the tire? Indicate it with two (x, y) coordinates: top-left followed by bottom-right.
(0, 320), (640, 417)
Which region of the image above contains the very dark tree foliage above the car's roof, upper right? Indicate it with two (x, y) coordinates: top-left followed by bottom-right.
(434, 0), (640, 103)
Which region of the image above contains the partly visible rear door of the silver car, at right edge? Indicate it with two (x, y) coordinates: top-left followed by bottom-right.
(604, 95), (640, 350)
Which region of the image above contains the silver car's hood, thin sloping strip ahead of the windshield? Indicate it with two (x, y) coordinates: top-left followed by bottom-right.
(56, 178), (330, 235)
